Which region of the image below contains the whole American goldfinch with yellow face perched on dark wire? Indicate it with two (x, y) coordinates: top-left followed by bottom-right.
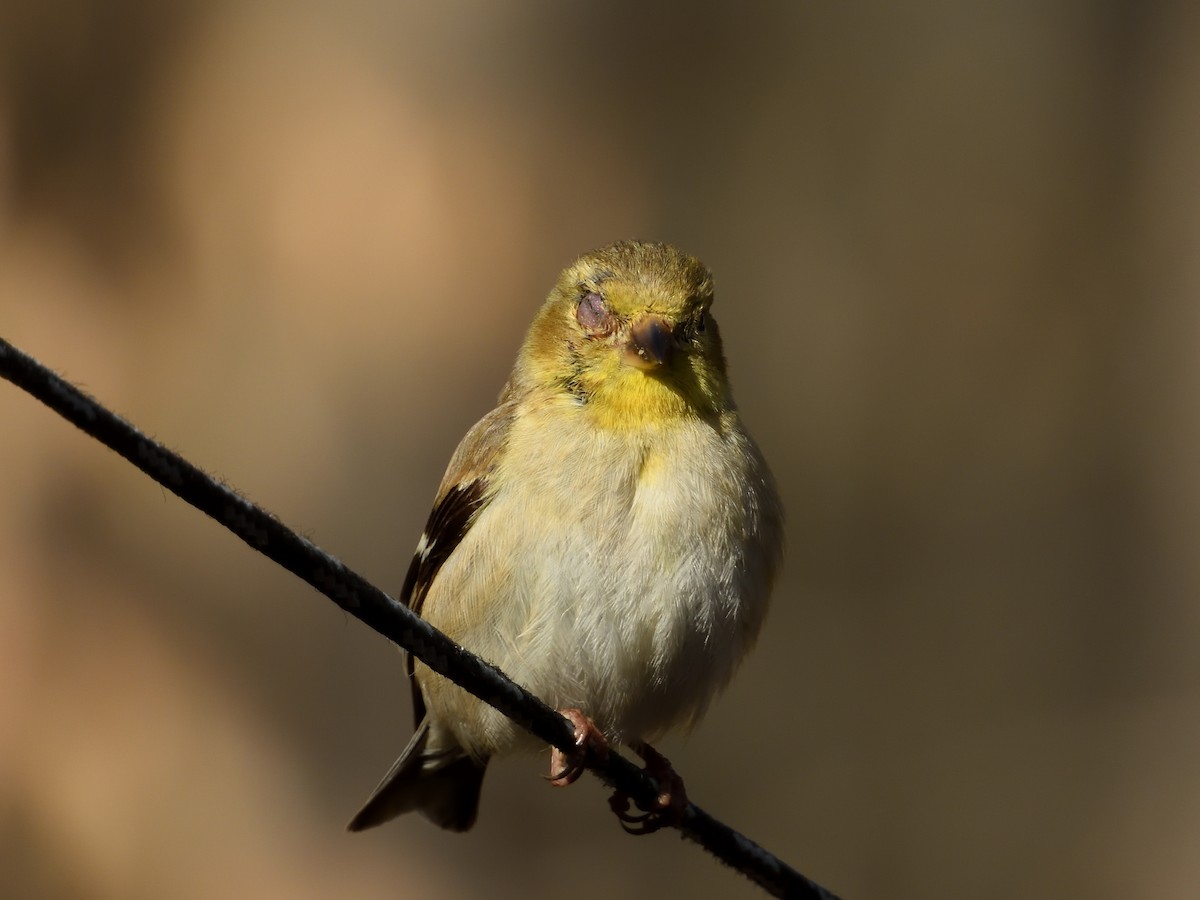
(349, 241), (782, 832)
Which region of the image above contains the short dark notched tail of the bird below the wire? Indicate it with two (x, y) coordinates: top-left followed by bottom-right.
(347, 716), (487, 832)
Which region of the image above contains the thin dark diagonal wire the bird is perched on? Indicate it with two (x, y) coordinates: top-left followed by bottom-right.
(0, 338), (838, 900)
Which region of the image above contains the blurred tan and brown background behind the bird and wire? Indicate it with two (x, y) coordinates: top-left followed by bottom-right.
(0, 0), (1200, 900)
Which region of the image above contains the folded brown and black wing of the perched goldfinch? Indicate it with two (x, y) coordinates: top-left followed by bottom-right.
(400, 391), (516, 726)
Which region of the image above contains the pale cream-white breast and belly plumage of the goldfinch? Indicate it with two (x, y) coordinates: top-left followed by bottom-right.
(425, 398), (779, 752)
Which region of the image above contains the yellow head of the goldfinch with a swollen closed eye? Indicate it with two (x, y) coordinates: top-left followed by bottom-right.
(517, 241), (728, 428)
